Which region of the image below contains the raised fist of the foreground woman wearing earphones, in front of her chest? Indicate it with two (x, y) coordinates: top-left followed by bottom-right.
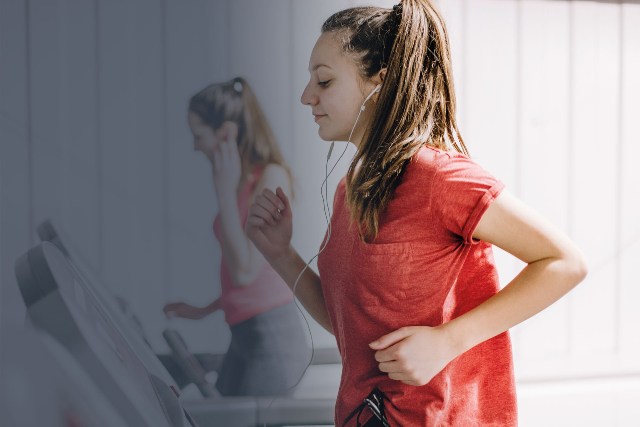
(245, 187), (293, 262)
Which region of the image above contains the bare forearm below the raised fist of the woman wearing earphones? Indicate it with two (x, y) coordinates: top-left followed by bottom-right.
(269, 247), (333, 334)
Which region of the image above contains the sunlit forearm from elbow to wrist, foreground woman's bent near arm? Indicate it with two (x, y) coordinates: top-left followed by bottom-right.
(443, 256), (586, 353)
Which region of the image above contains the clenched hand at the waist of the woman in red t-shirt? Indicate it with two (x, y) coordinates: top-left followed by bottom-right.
(369, 326), (459, 386)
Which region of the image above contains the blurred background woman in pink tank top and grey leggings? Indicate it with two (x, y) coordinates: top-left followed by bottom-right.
(164, 78), (310, 396)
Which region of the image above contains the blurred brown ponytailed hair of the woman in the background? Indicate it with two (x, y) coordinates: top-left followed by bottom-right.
(189, 77), (292, 191)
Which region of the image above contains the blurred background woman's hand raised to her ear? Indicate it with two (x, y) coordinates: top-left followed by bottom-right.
(208, 121), (242, 196)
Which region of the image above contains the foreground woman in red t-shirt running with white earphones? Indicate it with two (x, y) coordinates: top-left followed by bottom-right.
(246, 0), (586, 426)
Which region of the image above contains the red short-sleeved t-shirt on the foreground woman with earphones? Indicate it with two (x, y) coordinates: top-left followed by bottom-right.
(318, 147), (517, 427)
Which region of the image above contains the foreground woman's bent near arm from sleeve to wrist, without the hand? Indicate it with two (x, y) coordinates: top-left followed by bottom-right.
(447, 193), (587, 352)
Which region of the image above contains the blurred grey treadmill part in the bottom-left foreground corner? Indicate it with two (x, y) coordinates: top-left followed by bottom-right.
(0, 325), (131, 427)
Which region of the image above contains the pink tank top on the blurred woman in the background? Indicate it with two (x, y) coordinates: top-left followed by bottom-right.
(213, 167), (293, 325)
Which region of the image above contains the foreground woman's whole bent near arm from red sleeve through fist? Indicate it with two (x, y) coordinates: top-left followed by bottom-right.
(370, 192), (587, 385)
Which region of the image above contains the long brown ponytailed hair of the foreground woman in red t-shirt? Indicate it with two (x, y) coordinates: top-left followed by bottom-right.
(322, 0), (468, 240)
